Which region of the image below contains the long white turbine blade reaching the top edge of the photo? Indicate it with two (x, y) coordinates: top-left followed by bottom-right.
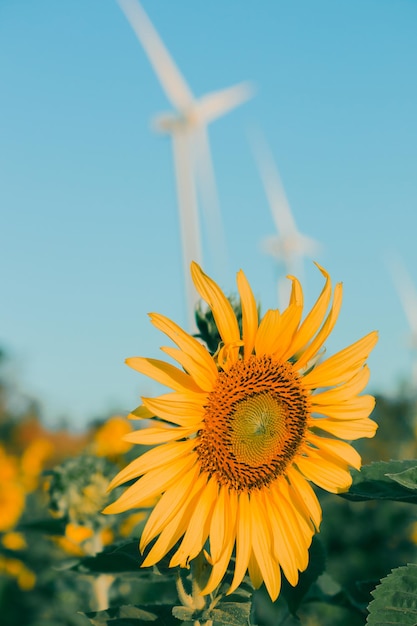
(117, 0), (194, 111)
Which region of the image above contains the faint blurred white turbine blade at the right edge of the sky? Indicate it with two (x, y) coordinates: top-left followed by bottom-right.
(389, 258), (417, 388)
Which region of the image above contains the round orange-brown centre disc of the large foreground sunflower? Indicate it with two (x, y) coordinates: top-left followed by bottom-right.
(197, 356), (310, 491)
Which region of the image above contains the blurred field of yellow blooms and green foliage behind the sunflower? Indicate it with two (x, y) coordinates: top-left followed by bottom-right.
(0, 352), (417, 626)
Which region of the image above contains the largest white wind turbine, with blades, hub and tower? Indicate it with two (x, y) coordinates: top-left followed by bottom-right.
(117, 0), (252, 329)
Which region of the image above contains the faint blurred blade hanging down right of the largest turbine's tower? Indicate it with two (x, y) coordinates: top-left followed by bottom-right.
(194, 125), (228, 276)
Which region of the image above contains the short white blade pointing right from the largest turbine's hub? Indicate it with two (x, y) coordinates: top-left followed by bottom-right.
(195, 82), (254, 124)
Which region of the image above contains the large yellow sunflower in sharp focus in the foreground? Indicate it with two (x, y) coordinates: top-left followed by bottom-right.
(105, 263), (377, 600)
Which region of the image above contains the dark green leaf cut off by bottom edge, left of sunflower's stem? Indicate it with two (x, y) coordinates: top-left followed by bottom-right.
(81, 604), (179, 626)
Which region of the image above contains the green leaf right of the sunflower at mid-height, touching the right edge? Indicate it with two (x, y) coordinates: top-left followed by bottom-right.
(340, 459), (417, 503)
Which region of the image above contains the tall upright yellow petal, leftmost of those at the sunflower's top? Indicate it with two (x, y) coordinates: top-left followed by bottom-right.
(191, 262), (240, 358)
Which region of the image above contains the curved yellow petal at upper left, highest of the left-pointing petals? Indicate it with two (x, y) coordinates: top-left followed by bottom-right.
(150, 313), (218, 386)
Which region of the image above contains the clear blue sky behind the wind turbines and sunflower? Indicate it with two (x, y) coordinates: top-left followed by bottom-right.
(0, 0), (417, 427)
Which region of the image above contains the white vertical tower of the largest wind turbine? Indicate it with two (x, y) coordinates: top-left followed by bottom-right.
(172, 129), (202, 332)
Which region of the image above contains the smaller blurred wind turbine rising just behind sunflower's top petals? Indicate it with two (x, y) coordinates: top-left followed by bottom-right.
(253, 134), (320, 308)
